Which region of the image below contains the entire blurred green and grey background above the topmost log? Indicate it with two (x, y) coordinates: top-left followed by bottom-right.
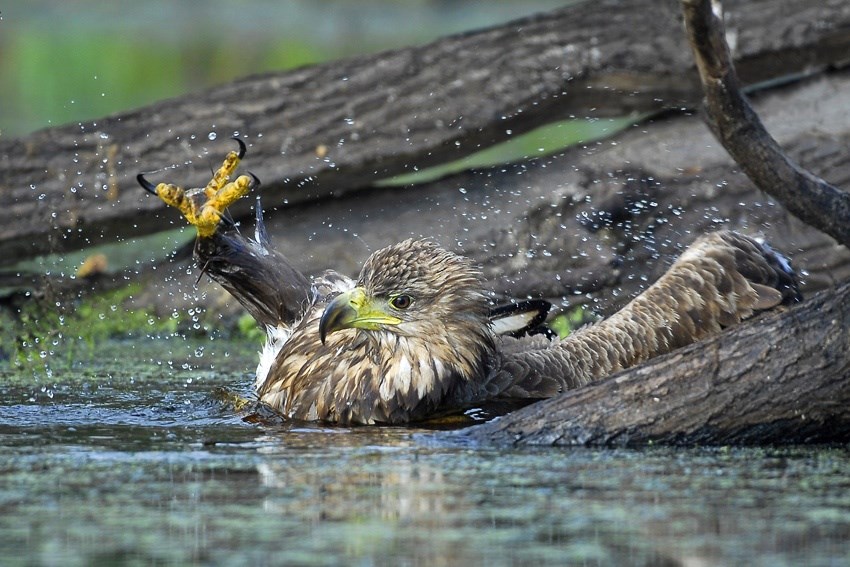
(0, 0), (570, 137)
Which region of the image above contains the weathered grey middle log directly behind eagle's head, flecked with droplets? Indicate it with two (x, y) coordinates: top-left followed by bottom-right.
(126, 73), (850, 322)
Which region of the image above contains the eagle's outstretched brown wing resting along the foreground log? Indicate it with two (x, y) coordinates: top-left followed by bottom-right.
(490, 231), (800, 398)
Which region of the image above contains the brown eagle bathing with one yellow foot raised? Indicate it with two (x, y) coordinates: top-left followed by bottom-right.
(137, 139), (800, 425)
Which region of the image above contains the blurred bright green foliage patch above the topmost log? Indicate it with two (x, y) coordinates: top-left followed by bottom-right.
(0, 29), (327, 135)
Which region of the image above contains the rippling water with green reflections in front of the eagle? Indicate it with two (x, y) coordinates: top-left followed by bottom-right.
(0, 341), (850, 565)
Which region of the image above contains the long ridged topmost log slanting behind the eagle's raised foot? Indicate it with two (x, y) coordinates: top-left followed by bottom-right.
(0, 0), (850, 265)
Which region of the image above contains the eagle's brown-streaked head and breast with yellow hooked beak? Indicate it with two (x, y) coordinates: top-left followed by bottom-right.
(260, 240), (494, 423)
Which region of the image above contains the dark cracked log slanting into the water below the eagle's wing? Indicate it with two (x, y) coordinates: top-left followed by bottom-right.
(459, 284), (850, 446)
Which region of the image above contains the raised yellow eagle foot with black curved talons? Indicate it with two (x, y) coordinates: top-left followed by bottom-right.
(136, 138), (260, 238)
